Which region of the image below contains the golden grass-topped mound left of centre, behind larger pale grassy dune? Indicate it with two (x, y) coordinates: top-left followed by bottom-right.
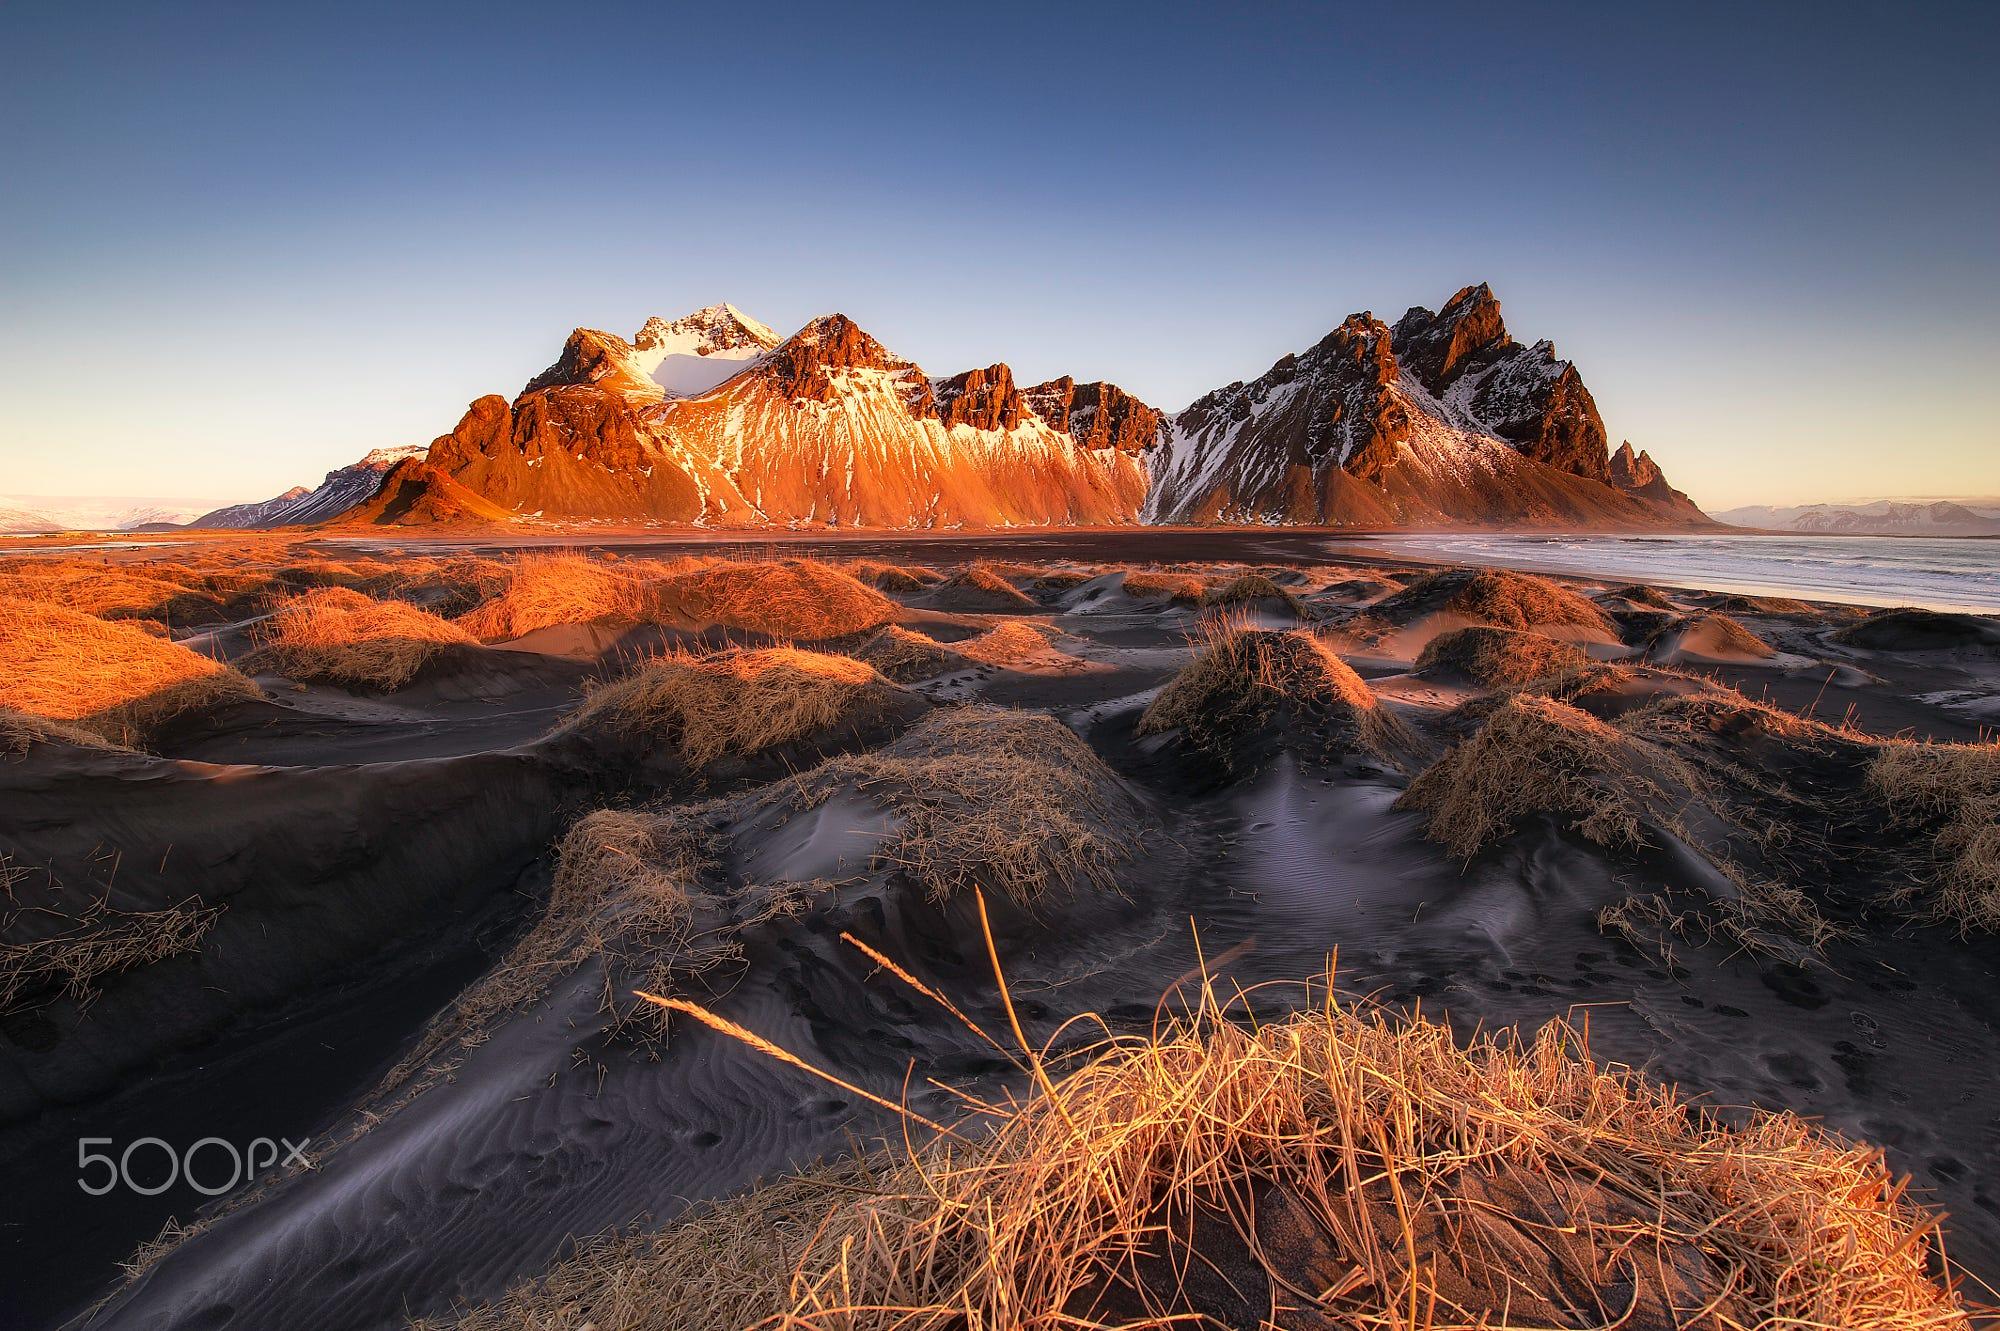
(568, 648), (900, 765)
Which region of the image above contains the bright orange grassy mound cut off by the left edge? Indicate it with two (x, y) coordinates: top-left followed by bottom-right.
(0, 596), (258, 745)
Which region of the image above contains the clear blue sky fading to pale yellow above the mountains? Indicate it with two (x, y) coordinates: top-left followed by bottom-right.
(0, 0), (2000, 508)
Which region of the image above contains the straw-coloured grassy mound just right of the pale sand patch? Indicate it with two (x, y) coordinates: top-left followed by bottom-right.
(1396, 693), (1694, 859)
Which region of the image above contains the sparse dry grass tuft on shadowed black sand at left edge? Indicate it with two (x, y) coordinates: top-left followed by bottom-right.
(0, 891), (222, 1015)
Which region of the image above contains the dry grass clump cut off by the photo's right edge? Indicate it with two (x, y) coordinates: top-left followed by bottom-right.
(1868, 741), (2000, 933)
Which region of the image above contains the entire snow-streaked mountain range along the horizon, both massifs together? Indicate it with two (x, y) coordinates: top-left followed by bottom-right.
(109, 284), (1708, 528)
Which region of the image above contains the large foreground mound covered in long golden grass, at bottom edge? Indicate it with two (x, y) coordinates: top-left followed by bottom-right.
(446, 963), (1968, 1331)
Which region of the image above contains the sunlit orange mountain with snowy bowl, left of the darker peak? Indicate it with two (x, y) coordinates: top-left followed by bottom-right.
(414, 306), (1160, 528)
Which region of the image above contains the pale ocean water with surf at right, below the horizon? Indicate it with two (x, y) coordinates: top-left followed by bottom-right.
(1358, 534), (2000, 614)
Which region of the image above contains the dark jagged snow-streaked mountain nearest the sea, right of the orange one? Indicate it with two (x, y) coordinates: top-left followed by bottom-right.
(1144, 284), (1706, 528)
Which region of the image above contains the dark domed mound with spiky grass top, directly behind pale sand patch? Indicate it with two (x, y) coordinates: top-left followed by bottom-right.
(1138, 624), (1410, 769)
